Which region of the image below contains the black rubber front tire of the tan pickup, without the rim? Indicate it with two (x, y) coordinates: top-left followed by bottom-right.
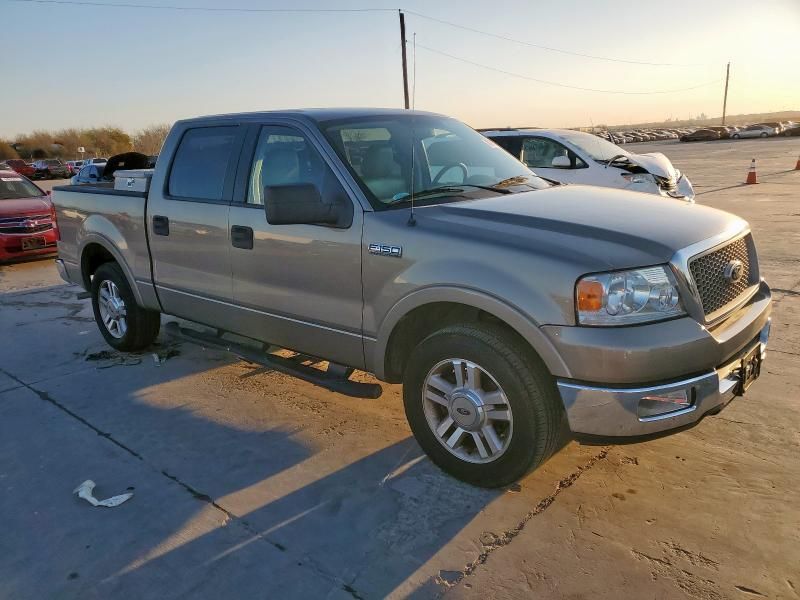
(403, 324), (565, 488)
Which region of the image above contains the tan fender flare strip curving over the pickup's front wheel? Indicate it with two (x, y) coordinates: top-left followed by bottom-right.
(372, 286), (570, 379)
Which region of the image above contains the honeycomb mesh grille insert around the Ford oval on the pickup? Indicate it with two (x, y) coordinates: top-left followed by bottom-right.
(689, 234), (758, 316)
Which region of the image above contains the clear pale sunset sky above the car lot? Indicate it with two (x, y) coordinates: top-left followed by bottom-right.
(0, 0), (800, 139)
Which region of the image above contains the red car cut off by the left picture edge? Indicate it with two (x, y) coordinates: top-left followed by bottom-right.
(0, 171), (58, 263)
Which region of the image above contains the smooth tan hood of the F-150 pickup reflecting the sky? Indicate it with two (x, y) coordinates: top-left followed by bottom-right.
(431, 185), (747, 272)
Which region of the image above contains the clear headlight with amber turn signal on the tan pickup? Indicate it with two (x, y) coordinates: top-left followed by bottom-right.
(575, 266), (686, 326)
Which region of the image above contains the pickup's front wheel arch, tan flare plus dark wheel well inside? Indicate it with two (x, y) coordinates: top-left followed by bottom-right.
(373, 288), (570, 383)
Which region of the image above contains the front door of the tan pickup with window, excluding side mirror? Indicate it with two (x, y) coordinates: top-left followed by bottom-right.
(223, 124), (364, 367)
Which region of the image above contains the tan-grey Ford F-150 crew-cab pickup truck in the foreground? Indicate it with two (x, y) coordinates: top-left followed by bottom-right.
(53, 109), (771, 486)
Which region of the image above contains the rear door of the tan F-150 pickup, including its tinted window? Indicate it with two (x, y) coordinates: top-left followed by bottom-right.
(147, 121), (245, 328)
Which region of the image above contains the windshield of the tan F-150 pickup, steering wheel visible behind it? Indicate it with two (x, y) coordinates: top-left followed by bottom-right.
(321, 113), (549, 209)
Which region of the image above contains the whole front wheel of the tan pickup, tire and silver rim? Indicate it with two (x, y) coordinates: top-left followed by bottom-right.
(403, 325), (564, 487)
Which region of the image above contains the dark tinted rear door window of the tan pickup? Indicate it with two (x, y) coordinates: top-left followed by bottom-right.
(169, 126), (238, 200)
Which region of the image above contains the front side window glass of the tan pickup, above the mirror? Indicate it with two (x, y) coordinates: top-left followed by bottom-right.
(247, 126), (328, 205)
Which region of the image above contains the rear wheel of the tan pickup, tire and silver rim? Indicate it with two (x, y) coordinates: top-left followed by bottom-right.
(92, 262), (161, 352)
